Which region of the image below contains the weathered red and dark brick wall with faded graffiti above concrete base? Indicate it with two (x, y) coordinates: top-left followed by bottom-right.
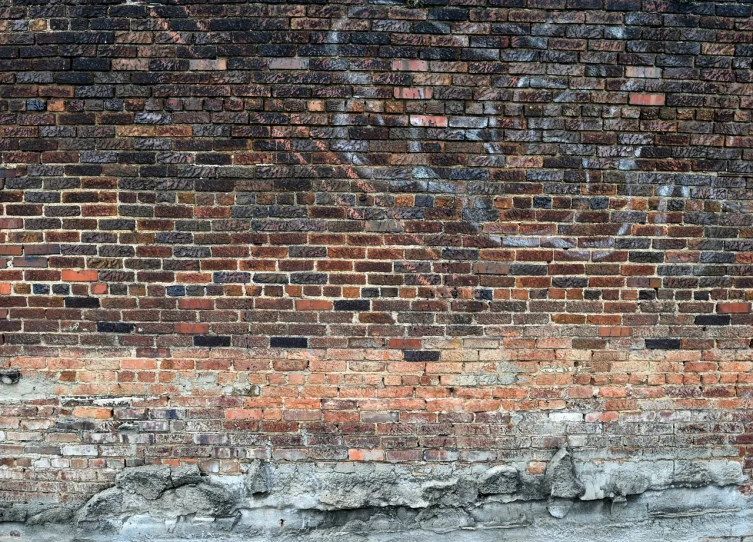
(0, 0), (753, 516)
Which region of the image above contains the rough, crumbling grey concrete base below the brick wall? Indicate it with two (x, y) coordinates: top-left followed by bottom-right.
(0, 454), (753, 542)
